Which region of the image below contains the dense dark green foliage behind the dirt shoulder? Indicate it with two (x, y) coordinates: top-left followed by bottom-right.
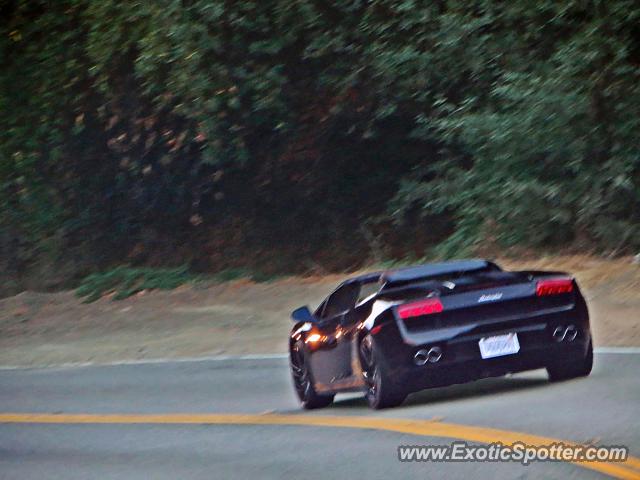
(0, 0), (640, 286)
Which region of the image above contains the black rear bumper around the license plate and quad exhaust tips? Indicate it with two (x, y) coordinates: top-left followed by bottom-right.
(386, 310), (591, 391)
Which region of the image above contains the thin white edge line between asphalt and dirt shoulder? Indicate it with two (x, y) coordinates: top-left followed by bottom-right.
(0, 347), (640, 370)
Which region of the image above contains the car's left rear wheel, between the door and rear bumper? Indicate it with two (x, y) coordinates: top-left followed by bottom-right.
(358, 335), (407, 410)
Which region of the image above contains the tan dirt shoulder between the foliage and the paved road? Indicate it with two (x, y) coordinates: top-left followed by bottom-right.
(0, 256), (640, 366)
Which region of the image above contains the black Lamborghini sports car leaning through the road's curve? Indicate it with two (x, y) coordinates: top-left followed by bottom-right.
(289, 260), (593, 409)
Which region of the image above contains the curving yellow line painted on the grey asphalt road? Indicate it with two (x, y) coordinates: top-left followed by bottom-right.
(0, 413), (640, 480)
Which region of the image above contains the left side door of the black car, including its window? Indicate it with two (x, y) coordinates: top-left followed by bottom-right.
(310, 283), (359, 387)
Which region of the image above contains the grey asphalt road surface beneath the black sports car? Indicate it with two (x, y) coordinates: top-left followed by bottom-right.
(0, 354), (640, 480)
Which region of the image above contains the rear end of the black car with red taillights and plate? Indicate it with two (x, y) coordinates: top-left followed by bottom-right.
(379, 270), (591, 390)
